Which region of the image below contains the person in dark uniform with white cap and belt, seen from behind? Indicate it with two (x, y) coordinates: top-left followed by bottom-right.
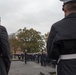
(47, 0), (76, 75)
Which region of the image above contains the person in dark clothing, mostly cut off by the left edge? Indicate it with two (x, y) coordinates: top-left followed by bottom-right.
(0, 25), (11, 75)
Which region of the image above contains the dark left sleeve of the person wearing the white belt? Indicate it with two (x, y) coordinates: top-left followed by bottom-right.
(47, 26), (58, 60)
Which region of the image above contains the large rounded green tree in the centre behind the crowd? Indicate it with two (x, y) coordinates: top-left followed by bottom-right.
(17, 28), (44, 52)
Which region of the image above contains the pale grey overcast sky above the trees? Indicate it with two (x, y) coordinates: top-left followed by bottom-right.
(0, 0), (64, 34)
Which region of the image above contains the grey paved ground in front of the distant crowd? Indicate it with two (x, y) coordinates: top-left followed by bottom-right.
(9, 61), (55, 75)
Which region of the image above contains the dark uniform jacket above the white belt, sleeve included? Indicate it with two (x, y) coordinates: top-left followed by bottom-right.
(47, 13), (76, 60)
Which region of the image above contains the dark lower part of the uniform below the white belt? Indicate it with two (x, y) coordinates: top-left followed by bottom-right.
(57, 59), (76, 75)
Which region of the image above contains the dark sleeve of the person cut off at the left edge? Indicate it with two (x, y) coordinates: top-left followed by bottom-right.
(0, 27), (11, 73)
